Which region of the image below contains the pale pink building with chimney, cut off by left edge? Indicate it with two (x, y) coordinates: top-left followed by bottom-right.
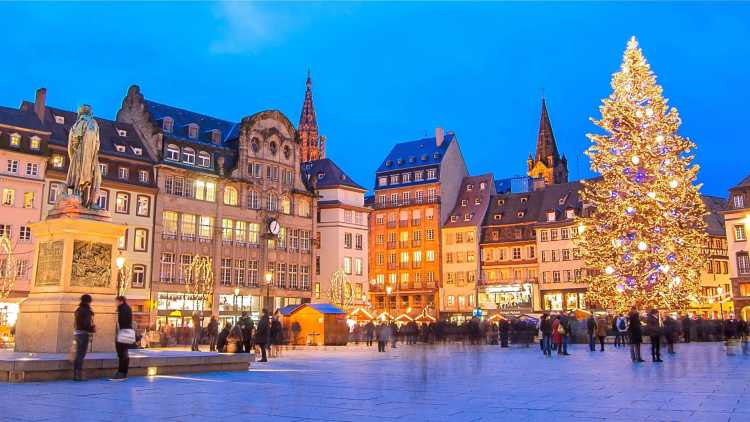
(0, 89), (50, 326)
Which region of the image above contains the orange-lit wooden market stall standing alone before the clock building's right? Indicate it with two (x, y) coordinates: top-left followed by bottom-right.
(283, 303), (349, 346)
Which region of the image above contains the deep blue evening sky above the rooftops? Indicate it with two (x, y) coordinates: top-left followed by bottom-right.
(0, 2), (750, 196)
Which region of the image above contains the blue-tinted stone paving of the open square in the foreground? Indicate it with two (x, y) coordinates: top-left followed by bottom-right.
(0, 343), (750, 422)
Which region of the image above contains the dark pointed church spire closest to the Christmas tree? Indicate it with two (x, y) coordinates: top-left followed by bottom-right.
(527, 97), (568, 185)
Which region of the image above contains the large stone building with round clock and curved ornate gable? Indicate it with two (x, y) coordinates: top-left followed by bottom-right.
(117, 86), (316, 324)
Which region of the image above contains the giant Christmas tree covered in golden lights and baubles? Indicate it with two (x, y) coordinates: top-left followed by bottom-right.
(579, 37), (706, 310)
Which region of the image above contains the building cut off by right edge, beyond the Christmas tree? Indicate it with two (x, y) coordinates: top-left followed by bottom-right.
(723, 175), (750, 321)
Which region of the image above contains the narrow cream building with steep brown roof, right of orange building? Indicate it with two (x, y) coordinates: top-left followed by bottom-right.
(440, 173), (495, 321)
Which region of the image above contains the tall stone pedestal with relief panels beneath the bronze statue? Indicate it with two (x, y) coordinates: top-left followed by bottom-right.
(16, 201), (125, 353)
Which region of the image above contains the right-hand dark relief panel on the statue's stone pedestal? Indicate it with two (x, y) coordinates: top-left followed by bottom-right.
(70, 240), (112, 287)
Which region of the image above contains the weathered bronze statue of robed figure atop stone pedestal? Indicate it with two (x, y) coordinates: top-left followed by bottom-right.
(67, 104), (102, 208)
